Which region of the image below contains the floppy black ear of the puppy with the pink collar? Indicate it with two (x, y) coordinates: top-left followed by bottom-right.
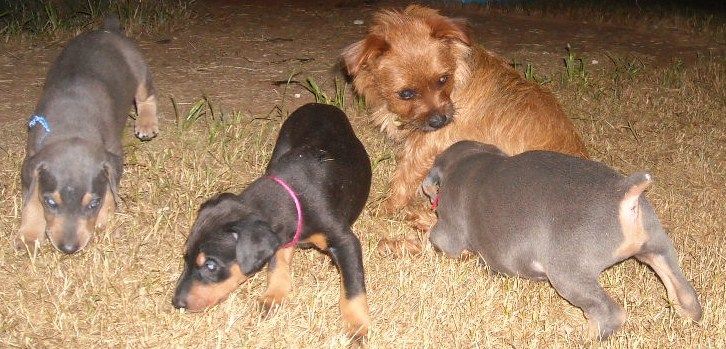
(233, 220), (281, 276)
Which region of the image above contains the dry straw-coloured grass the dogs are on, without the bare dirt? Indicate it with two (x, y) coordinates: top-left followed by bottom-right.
(0, 10), (726, 348)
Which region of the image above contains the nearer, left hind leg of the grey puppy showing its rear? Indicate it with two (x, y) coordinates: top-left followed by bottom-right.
(547, 271), (626, 340)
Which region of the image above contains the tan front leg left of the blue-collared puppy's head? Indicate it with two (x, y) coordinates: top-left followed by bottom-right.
(15, 180), (46, 251)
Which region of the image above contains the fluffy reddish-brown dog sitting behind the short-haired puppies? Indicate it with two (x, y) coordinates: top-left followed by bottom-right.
(343, 5), (587, 229)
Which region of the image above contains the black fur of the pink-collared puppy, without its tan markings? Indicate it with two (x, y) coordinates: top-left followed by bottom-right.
(172, 104), (371, 308)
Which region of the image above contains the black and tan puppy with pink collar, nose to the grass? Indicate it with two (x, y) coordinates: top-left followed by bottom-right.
(172, 104), (371, 336)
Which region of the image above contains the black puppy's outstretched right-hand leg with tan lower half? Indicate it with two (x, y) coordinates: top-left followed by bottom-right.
(328, 228), (370, 339)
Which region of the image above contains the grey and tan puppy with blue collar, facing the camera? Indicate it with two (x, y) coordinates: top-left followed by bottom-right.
(15, 19), (158, 253)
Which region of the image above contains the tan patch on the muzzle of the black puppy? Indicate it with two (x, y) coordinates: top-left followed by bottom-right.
(186, 263), (247, 311)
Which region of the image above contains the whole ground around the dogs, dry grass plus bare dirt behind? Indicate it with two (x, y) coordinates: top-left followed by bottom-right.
(0, 0), (726, 348)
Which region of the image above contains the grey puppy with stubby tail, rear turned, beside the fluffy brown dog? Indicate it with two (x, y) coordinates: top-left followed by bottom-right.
(421, 141), (702, 339)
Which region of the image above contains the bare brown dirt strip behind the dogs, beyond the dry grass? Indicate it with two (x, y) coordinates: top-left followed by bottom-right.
(0, 1), (724, 122)
